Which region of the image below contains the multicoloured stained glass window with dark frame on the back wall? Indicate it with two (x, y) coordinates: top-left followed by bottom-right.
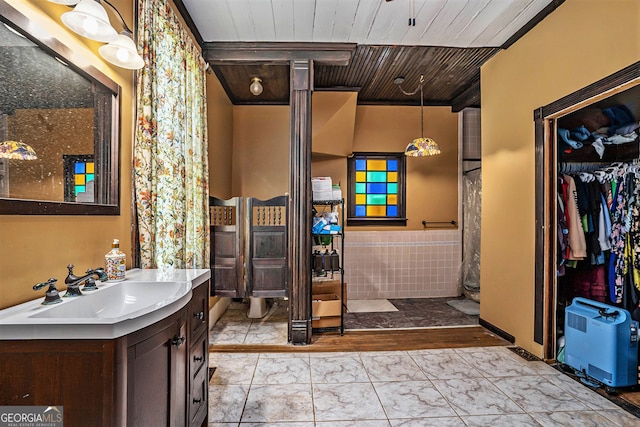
(347, 153), (406, 225)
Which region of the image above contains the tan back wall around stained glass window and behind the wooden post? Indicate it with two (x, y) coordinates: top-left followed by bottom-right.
(233, 96), (458, 227)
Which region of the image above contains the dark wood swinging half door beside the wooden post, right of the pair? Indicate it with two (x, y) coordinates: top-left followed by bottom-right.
(246, 196), (288, 298)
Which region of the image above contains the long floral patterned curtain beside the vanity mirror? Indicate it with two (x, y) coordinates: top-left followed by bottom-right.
(133, 0), (209, 268)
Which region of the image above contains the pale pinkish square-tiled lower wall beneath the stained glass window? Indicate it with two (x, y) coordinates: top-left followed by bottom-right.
(344, 230), (461, 299)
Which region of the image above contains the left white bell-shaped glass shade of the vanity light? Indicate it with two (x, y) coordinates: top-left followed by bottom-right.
(60, 0), (118, 43)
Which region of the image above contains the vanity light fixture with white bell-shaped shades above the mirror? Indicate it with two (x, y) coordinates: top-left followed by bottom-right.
(49, 0), (144, 70)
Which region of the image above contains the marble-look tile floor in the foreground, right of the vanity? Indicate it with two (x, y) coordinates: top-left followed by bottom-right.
(209, 346), (640, 427)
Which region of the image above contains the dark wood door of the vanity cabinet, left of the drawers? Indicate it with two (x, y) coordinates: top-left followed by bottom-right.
(127, 316), (187, 427)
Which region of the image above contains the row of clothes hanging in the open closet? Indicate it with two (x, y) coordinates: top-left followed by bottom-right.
(556, 164), (640, 319)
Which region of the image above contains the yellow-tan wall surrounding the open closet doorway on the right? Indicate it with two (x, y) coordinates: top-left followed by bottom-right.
(480, 0), (640, 356)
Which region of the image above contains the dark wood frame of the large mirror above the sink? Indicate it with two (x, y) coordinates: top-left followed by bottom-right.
(0, 0), (122, 215)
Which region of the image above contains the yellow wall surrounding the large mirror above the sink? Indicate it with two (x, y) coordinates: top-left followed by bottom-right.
(0, 0), (134, 308)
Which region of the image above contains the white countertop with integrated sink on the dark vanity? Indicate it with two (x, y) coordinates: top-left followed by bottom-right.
(0, 269), (211, 340)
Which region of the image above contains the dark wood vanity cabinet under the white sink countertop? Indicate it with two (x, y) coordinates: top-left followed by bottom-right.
(0, 281), (209, 427)
